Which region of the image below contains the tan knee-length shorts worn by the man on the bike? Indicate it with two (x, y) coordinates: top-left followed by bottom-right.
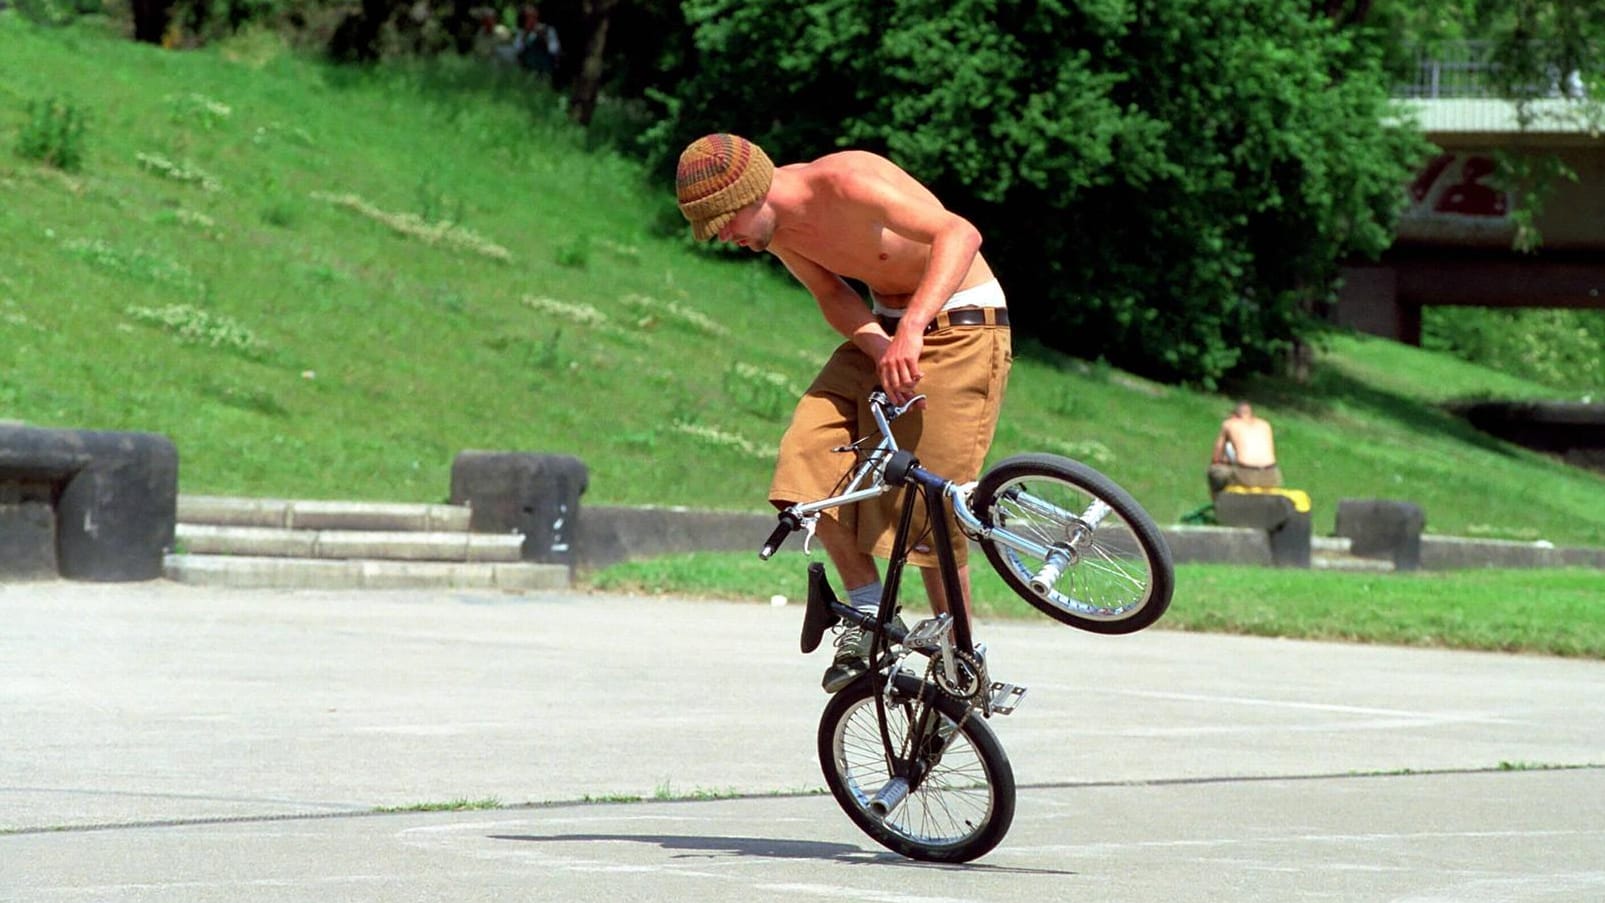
(769, 317), (1014, 568)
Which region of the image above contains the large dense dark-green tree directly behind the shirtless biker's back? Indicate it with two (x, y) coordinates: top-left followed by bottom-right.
(650, 0), (1424, 385)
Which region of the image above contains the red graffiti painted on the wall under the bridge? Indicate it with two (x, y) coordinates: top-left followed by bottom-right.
(1398, 152), (1515, 244)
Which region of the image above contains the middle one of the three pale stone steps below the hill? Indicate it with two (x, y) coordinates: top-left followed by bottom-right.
(175, 523), (523, 561)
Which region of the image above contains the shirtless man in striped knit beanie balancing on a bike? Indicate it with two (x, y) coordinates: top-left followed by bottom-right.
(676, 135), (1013, 693)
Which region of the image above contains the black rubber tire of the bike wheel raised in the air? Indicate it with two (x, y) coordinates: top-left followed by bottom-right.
(969, 454), (1175, 634)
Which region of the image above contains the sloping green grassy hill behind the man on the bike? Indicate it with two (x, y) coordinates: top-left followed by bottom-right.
(0, 13), (1605, 545)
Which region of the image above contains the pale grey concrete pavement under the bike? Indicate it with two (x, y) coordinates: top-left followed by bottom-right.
(0, 583), (1605, 901)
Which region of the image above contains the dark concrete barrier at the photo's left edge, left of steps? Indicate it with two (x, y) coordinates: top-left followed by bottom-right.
(0, 425), (178, 582)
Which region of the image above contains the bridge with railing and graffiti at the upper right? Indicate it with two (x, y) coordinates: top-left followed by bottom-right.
(1335, 42), (1605, 345)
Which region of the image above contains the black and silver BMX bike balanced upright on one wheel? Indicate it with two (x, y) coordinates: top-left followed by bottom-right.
(759, 390), (1175, 863)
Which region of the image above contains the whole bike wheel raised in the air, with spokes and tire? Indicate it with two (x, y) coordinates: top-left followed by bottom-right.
(969, 454), (1175, 634)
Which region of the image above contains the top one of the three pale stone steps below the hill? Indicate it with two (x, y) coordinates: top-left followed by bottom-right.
(178, 496), (470, 532)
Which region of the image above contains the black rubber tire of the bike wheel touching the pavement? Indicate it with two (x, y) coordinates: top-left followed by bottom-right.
(819, 672), (1014, 863)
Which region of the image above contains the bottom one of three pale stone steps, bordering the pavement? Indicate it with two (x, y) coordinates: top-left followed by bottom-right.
(164, 555), (568, 590)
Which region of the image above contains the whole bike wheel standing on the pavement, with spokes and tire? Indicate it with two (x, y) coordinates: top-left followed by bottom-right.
(819, 674), (1014, 863)
